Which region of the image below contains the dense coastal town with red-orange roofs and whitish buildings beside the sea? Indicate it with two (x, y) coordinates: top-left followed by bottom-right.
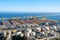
(0, 17), (60, 40)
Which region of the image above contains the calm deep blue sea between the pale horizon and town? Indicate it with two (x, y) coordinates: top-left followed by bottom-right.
(0, 12), (60, 20)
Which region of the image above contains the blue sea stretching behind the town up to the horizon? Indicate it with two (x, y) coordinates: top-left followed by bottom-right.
(0, 12), (60, 25)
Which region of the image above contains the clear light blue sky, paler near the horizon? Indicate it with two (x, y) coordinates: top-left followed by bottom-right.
(0, 0), (60, 12)
